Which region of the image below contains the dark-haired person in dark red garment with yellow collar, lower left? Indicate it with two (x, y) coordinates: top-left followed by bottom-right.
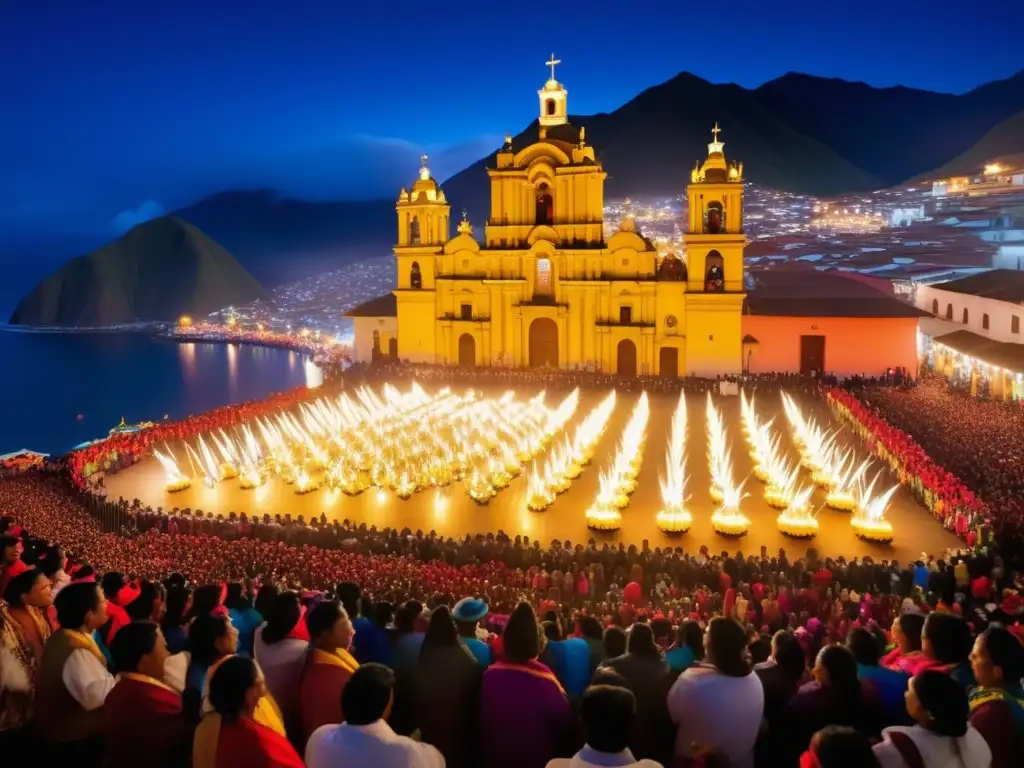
(103, 622), (191, 768)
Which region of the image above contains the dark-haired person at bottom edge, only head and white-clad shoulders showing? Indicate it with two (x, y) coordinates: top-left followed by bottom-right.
(547, 685), (662, 768)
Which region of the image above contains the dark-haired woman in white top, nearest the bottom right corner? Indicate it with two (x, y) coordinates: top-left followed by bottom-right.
(874, 670), (991, 768)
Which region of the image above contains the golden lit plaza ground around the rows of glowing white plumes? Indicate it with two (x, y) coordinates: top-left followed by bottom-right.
(105, 389), (962, 562)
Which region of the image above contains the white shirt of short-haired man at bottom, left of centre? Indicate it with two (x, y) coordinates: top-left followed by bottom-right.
(306, 720), (444, 768)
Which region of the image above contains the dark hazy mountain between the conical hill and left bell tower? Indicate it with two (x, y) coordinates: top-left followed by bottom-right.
(173, 189), (398, 286)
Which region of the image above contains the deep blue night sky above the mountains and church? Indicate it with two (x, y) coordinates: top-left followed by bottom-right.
(0, 0), (1024, 241)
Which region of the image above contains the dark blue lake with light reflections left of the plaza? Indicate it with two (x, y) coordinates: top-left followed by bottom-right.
(0, 330), (322, 454)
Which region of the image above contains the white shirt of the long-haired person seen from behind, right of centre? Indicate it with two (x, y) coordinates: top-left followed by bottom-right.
(669, 666), (765, 768)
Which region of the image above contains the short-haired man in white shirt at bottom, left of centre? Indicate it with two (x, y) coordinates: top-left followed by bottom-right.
(306, 664), (444, 768)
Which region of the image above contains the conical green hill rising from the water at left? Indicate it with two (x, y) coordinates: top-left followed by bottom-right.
(10, 216), (263, 327)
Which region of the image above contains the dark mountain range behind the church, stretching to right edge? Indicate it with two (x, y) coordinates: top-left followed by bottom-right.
(444, 72), (1024, 227)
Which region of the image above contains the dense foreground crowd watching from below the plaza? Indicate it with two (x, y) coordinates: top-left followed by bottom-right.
(0, 474), (1024, 768)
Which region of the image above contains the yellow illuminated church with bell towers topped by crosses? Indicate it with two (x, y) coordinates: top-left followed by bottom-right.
(347, 56), (916, 376)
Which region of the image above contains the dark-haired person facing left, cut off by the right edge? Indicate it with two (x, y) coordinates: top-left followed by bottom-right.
(968, 627), (1024, 768)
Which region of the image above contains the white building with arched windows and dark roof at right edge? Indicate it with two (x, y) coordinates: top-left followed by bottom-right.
(914, 269), (1024, 344)
